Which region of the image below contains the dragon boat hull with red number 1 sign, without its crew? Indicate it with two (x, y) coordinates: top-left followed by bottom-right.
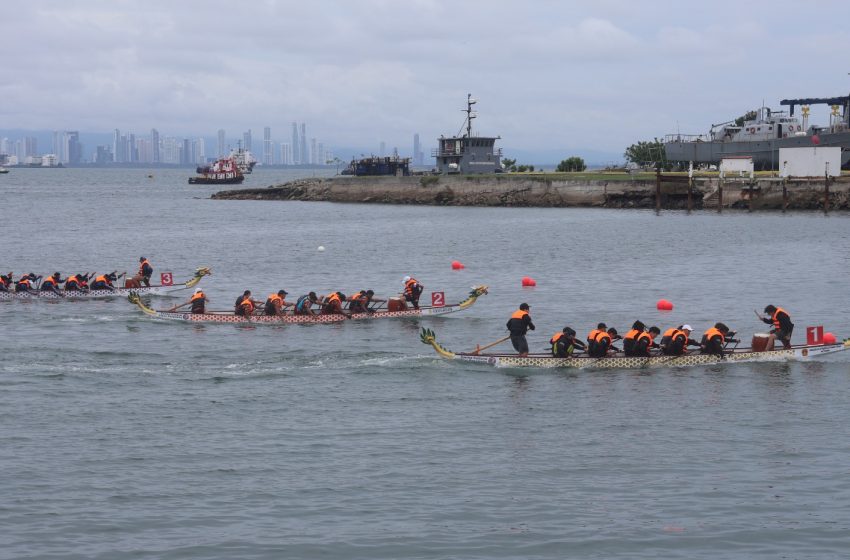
(419, 328), (850, 369)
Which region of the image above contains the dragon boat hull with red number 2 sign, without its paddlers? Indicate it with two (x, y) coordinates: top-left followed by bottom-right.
(127, 286), (487, 325)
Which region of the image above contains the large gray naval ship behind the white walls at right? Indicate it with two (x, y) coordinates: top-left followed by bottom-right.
(664, 95), (850, 169)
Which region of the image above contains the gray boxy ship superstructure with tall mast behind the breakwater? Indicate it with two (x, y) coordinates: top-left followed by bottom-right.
(431, 94), (502, 174)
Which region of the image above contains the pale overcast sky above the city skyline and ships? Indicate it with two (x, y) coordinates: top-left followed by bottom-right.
(0, 0), (850, 155)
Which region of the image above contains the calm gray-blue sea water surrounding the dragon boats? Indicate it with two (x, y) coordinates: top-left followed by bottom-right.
(0, 169), (850, 560)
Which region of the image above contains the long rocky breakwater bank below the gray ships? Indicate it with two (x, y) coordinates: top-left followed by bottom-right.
(212, 174), (850, 210)
